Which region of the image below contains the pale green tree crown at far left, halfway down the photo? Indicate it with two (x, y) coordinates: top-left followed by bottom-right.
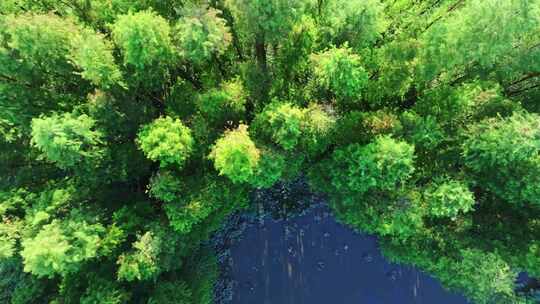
(32, 113), (102, 169)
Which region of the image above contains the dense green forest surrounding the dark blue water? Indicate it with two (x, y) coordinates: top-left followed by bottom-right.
(0, 0), (540, 304)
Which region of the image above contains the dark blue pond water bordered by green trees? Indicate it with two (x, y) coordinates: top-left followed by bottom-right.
(229, 207), (467, 304)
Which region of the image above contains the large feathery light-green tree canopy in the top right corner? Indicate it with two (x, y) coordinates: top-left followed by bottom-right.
(417, 0), (540, 82)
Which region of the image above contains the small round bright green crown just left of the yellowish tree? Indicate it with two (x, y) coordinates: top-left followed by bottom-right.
(137, 117), (193, 168)
